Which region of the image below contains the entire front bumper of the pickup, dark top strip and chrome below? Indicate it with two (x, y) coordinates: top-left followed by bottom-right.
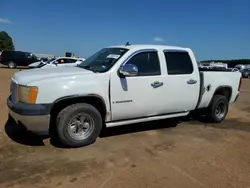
(7, 97), (51, 135)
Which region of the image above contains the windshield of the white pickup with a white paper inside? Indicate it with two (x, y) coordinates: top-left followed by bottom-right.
(78, 48), (128, 72)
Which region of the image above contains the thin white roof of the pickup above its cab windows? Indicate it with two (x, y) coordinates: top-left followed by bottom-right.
(110, 44), (189, 50)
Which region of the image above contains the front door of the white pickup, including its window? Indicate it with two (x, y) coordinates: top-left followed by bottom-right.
(110, 50), (165, 121)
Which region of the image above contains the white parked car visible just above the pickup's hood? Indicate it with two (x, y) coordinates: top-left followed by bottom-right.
(29, 57), (84, 68)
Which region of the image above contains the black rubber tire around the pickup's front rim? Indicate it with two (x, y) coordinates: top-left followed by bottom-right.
(56, 103), (103, 147)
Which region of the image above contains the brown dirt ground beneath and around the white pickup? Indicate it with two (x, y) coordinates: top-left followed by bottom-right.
(0, 68), (250, 188)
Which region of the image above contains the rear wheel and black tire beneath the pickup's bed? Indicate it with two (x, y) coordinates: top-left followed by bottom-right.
(206, 95), (229, 123)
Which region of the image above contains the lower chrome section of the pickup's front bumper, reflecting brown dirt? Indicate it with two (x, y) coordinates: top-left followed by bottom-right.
(9, 109), (50, 135)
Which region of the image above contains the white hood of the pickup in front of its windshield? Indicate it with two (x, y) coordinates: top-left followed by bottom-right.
(12, 67), (96, 85)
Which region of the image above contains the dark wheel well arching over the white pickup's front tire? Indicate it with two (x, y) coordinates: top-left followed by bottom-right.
(50, 96), (107, 131)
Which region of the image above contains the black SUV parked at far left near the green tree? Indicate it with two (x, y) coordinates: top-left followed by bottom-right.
(0, 51), (38, 68)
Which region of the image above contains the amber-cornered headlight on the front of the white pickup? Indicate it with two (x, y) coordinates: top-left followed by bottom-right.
(18, 86), (38, 104)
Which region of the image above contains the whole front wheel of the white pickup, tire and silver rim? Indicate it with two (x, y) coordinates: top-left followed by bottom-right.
(56, 103), (102, 147)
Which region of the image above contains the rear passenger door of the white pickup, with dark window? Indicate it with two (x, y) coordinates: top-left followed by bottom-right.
(164, 50), (200, 113)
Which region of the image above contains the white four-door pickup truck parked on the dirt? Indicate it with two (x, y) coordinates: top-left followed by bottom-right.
(8, 45), (241, 147)
